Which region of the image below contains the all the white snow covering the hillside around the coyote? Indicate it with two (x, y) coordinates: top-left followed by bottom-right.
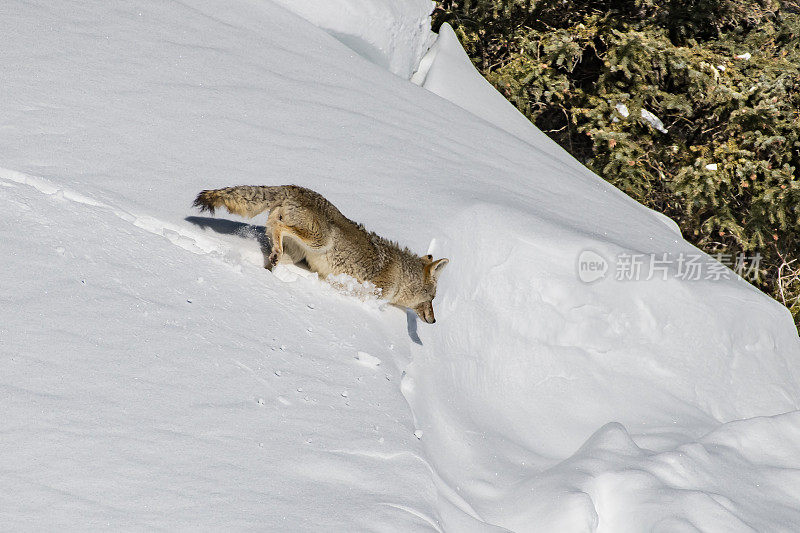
(0, 0), (800, 532)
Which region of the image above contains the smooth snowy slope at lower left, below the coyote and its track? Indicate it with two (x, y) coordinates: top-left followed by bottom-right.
(0, 173), (435, 531)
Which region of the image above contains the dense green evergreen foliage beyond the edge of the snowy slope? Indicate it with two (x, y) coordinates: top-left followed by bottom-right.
(434, 0), (800, 324)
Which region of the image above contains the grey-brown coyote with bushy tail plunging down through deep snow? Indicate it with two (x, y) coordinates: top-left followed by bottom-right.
(194, 185), (448, 324)
